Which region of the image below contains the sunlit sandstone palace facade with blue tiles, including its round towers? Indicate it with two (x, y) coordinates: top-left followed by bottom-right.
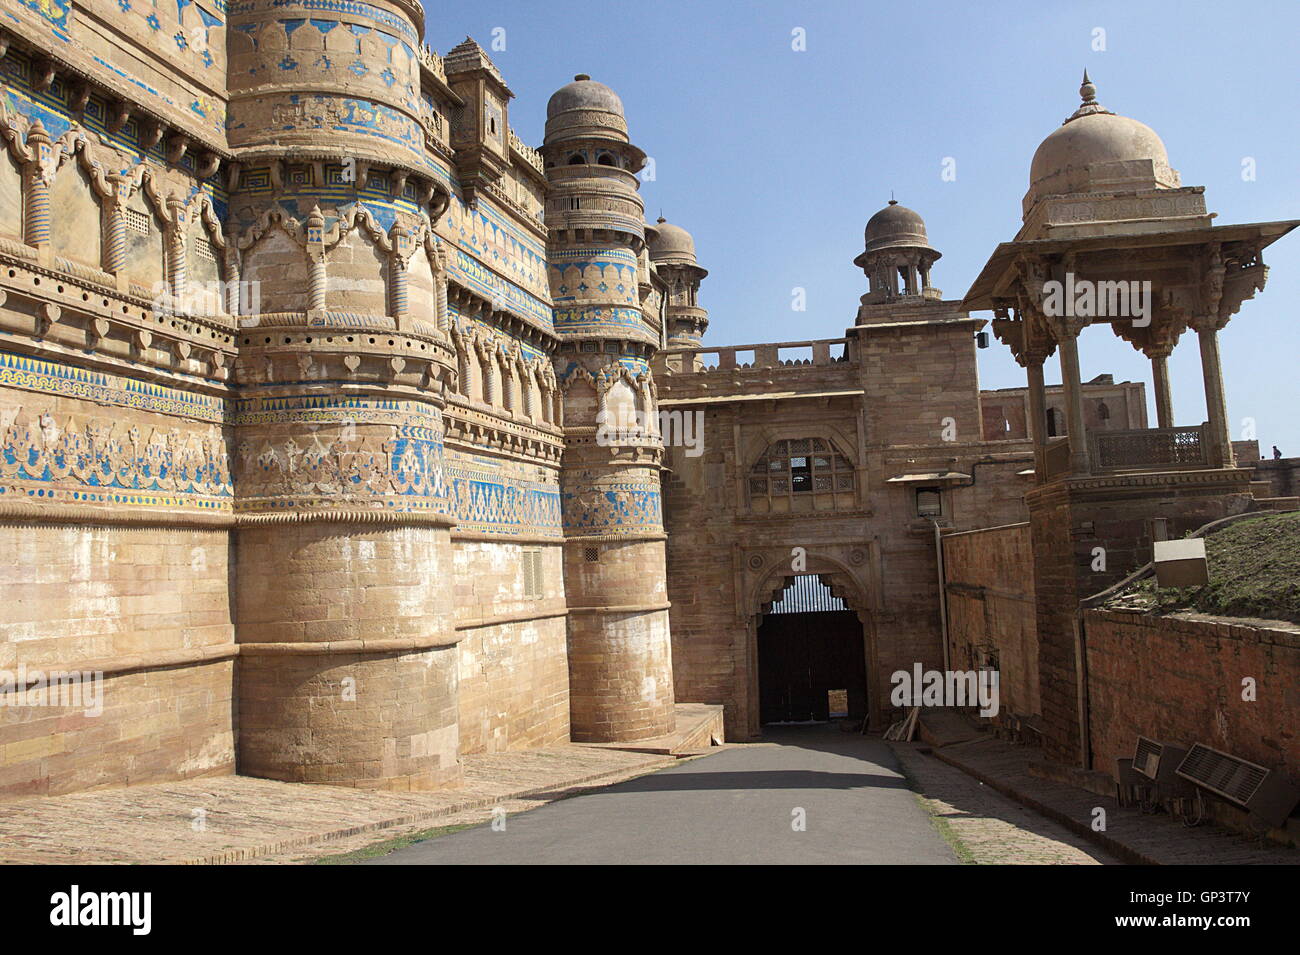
(0, 7), (673, 798)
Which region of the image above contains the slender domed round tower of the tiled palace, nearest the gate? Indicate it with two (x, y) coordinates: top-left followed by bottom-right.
(542, 74), (673, 742)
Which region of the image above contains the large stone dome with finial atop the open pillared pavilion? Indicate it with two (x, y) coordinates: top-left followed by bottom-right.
(1026, 73), (1179, 205)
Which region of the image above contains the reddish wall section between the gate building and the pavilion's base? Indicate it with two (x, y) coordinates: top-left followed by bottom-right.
(944, 524), (1041, 722)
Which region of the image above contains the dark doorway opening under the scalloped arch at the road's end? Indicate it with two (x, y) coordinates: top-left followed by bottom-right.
(758, 574), (867, 724)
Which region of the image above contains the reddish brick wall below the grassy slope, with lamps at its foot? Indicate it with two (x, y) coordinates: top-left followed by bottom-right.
(1083, 609), (1300, 783)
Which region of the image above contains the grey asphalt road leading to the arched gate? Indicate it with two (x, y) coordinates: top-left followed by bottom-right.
(367, 726), (957, 865)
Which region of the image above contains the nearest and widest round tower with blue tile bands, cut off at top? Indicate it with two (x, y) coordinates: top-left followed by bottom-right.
(225, 0), (460, 790)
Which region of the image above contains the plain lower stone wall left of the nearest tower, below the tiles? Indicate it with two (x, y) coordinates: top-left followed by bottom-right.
(0, 522), (235, 798)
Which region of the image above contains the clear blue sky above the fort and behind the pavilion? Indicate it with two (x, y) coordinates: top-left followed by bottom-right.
(425, 0), (1300, 455)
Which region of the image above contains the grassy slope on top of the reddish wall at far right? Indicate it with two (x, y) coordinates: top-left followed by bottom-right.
(1106, 512), (1300, 624)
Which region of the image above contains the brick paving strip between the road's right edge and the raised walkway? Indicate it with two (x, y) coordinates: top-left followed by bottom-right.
(891, 743), (1121, 865)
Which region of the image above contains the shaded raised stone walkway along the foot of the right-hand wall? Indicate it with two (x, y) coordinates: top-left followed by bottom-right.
(932, 737), (1300, 865)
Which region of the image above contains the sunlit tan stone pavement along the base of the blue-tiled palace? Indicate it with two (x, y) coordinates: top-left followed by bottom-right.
(0, 745), (677, 864)
